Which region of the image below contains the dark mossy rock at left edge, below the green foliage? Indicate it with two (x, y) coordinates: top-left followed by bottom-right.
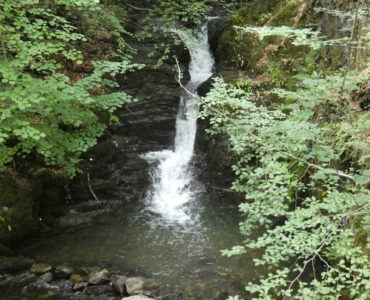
(0, 169), (67, 245)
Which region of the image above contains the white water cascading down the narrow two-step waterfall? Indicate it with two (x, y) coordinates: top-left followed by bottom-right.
(143, 24), (214, 224)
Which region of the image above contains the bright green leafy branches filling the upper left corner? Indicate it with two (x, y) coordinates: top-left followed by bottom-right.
(0, 0), (140, 176)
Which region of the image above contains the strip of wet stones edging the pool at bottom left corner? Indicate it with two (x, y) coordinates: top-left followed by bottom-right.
(0, 257), (159, 300)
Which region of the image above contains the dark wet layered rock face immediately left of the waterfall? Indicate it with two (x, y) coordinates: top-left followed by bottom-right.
(71, 7), (189, 206)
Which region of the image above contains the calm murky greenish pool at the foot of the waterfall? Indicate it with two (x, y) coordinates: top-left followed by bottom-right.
(13, 193), (259, 300)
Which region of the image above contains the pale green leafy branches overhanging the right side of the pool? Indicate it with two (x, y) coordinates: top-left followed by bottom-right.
(202, 74), (370, 300)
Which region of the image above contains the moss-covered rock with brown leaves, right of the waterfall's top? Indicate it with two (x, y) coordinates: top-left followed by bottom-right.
(216, 0), (308, 82)
